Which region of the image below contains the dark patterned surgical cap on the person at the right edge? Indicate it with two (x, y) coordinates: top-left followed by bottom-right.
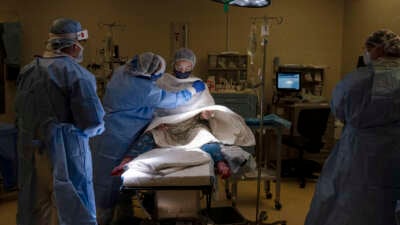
(365, 29), (400, 57)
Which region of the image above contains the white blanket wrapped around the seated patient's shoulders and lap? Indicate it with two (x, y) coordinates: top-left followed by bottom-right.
(151, 74), (255, 148)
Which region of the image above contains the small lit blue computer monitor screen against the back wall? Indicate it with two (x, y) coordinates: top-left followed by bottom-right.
(276, 72), (301, 91)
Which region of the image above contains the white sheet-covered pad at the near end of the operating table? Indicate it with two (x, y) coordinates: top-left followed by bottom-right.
(121, 149), (215, 187)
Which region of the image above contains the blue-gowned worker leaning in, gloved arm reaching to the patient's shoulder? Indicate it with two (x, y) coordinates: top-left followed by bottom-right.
(91, 52), (205, 225)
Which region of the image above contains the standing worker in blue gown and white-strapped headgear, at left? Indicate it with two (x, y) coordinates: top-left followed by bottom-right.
(15, 18), (104, 225)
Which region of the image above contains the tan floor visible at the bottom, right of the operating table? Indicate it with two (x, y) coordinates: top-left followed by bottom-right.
(0, 178), (315, 225)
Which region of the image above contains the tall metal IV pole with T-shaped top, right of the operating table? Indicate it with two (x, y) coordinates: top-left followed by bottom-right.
(250, 16), (286, 225)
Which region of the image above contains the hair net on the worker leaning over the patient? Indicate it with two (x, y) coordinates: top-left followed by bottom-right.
(128, 52), (165, 77)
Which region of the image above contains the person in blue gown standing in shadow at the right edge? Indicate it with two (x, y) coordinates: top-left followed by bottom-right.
(305, 30), (400, 225)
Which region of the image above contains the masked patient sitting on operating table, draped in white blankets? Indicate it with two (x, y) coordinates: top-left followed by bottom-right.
(113, 49), (255, 182)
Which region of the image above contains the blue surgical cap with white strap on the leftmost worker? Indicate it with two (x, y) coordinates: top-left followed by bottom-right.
(46, 18), (82, 50)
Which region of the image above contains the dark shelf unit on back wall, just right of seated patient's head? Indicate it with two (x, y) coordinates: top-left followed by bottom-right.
(208, 53), (248, 89)
